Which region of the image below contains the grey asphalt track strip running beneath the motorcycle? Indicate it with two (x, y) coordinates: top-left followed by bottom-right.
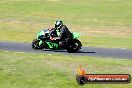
(0, 42), (132, 59)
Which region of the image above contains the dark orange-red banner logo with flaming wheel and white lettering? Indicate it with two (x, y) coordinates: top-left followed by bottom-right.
(76, 66), (131, 85)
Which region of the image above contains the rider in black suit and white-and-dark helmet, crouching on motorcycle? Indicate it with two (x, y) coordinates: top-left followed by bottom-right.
(51, 20), (72, 46)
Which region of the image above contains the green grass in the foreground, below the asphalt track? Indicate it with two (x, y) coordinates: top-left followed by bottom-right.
(0, 51), (132, 88)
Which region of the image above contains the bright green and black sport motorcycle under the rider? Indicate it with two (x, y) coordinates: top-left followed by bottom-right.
(32, 28), (82, 53)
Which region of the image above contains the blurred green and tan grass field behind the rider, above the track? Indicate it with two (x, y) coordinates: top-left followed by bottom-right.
(0, 0), (132, 48)
